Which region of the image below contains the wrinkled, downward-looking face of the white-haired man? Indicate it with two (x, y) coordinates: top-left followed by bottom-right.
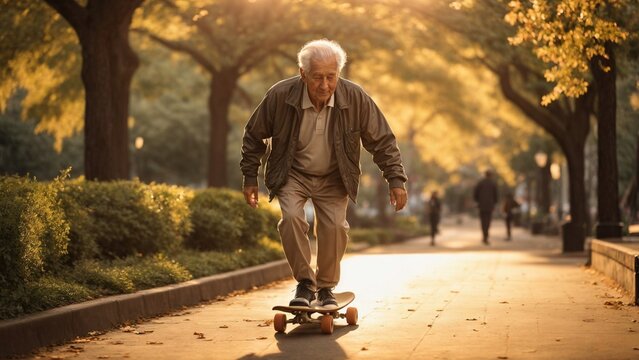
(300, 58), (339, 109)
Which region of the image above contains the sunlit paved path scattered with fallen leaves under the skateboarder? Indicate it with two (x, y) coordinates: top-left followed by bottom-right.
(30, 221), (639, 359)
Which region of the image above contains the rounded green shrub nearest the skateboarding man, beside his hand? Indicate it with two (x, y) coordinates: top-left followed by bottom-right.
(187, 189), (277, 251)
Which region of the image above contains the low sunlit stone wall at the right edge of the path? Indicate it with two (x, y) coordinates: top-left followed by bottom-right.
(591, 240), (639, 305)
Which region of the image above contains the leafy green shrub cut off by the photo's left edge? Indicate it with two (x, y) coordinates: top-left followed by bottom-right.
(0, 174), (69, 287)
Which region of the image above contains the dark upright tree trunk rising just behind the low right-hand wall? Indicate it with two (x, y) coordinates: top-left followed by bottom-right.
(590, 43), (622, 238)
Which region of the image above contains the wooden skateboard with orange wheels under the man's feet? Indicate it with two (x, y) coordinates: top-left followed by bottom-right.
(273, 292), (357, 334)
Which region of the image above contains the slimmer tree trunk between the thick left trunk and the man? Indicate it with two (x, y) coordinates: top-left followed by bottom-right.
(208, 68), (239, 187)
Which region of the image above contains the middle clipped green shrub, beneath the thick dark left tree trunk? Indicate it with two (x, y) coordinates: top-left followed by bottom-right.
(62, 180), (192, 262)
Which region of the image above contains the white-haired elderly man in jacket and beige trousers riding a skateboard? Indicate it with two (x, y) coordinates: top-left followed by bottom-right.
(240, 39), (407, 307)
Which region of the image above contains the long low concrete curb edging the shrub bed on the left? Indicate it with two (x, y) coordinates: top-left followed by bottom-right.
(0, 260), (291, 357)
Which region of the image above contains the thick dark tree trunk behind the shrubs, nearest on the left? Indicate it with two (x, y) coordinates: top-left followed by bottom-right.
(46, 0), (142, 181)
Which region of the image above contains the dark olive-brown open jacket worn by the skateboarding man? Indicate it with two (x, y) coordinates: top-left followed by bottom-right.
(240, 76), (407, 202)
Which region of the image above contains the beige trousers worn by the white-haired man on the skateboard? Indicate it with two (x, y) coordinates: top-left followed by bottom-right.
(277, 169), (349, 288)
